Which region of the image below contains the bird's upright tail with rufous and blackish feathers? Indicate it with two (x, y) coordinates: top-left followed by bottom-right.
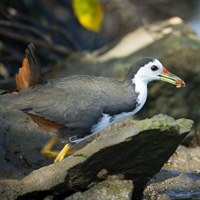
(0, 43), (43, 108)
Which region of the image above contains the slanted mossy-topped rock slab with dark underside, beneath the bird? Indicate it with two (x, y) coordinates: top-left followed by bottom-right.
(0, 105), (193, 200)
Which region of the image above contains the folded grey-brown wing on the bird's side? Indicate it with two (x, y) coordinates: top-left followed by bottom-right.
(0, 76), (111, 127)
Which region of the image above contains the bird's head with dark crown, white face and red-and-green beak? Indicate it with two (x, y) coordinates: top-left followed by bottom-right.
(126, 58), (185, 87)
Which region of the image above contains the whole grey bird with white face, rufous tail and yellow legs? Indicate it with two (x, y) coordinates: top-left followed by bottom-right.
(0, 43), (186, 163)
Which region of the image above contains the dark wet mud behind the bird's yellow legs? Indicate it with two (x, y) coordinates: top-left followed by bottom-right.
(0, 105), (63, 179)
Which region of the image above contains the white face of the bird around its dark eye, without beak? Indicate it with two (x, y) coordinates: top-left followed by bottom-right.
(132, 59), (163, 84)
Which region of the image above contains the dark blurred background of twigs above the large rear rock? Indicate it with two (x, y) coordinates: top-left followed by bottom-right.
(0, 0), (199, 79)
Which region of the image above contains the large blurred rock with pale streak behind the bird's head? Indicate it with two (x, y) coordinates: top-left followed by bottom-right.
(46, 18), (200, 122)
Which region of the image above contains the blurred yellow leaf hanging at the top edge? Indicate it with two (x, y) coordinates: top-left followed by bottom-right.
(73, 0), (103, 32)
